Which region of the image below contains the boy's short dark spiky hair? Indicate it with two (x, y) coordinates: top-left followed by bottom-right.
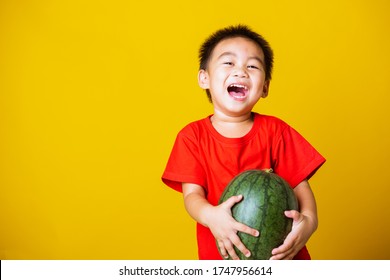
(199, 25), (273, 102)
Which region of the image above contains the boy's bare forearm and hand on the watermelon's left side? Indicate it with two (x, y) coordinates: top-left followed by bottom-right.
(183, 183), (259, 259)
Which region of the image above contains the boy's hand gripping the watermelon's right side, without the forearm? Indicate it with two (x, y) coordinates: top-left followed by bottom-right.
(271, 210), (315, 260)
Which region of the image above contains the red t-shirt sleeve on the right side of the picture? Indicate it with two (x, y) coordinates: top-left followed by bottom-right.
(273, 126), (325, 188)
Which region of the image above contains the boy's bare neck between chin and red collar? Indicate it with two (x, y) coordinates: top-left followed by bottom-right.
(210, 112), (253, 138)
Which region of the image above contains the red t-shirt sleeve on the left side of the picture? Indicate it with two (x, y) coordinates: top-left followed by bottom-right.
(162, 128), (206, 192)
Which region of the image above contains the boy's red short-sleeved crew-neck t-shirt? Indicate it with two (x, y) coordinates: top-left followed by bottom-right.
(162, 113), (325, 260)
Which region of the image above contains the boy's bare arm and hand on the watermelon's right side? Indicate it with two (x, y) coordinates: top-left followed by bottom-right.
(271, 180), (318, 260)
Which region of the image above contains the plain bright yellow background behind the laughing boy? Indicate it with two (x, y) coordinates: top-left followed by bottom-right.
(0, 0), (390, 259)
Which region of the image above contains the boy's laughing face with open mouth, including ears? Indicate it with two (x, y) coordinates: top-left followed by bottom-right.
(198, 37), (269, 117)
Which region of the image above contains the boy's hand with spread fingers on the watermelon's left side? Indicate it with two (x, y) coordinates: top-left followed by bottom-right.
(208, 195), (259, 260)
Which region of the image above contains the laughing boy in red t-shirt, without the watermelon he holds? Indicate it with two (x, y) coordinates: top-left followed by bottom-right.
(162, 25), (325, 259)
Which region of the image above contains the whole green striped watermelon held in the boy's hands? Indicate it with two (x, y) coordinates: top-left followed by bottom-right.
(218, 170), (298, 260)
